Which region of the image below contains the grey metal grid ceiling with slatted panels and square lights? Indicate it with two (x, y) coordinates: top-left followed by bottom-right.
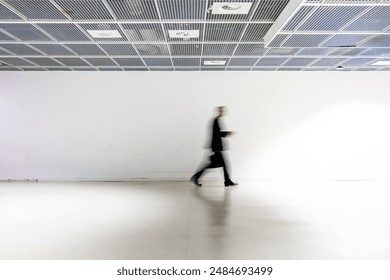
(0, 0), (390, 71)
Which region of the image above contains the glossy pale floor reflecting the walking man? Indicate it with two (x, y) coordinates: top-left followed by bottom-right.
(0, 182), (390, 259)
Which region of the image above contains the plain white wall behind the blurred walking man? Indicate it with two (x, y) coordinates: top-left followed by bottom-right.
(0, 72), (390, 180)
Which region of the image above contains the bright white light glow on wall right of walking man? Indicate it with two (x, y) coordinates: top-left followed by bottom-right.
(245, 101), (390, 180)
